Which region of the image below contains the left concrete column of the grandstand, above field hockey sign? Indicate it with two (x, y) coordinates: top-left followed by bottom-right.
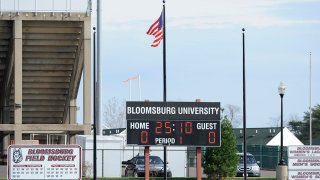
(14, 20), (22, 144)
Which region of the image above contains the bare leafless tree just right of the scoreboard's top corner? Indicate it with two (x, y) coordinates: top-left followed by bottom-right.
(224, 104), (242, 127)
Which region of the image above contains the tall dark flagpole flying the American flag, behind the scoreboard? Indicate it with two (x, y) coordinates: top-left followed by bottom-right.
(162, 0), (167, 180)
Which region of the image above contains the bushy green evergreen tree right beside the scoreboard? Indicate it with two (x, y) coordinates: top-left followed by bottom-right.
(204, 117), (239, 179)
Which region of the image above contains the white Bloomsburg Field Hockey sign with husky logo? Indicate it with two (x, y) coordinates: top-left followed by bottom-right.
(8, 145), (82, 180)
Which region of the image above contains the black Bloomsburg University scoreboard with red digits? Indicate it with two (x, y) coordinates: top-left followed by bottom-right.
(126, 102), (221, 146)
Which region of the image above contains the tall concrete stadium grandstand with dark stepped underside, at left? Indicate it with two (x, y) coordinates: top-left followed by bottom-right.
(0, 12), (92, 155)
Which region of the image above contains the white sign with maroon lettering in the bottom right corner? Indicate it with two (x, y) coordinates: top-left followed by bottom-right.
(288, 146), (320, 180)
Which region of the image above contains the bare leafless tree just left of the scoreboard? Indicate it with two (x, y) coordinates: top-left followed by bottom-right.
(103, 97), (126, 128)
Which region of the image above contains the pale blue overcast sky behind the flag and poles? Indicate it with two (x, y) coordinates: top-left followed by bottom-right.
(2, 0), (320, 127)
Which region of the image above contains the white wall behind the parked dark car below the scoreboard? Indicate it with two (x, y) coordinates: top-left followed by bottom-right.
(76, 135), (187, 177)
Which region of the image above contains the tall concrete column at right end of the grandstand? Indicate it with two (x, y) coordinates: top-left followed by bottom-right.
(83, 20), (92, 135)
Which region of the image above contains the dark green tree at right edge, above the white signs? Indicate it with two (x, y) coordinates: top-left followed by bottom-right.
(289, 104), (320, 145)
